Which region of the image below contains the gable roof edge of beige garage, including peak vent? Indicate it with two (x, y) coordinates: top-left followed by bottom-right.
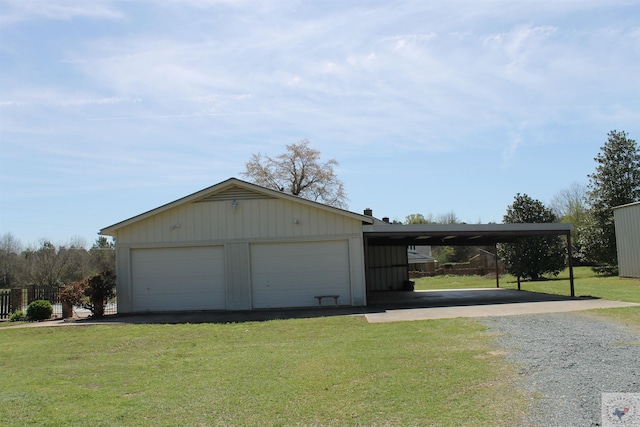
(98, 178), (373, 236)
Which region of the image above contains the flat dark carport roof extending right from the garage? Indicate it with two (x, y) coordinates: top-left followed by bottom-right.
(363, 223), (573, 246)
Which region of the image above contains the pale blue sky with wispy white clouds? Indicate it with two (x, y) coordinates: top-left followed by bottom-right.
(0, 0), (640, 246)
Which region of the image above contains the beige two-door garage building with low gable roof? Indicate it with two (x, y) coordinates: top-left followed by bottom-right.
(100, 178), (373, 313)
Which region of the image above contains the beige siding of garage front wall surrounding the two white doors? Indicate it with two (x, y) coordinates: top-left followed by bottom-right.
(115, 197), (366, 313)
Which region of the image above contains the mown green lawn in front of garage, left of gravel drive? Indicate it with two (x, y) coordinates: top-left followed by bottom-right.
(0, 317), (525, 426)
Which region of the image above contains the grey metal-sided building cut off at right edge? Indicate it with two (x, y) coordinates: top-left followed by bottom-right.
(613, 202), (640, 278)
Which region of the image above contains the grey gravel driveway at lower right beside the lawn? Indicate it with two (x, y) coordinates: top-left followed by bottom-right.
(479, 313), (640, 427)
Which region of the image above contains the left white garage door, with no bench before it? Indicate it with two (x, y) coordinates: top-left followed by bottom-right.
(131, 246), (225, 311)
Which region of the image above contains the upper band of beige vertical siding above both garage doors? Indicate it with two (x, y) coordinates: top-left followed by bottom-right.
(116, 199), (362, 245)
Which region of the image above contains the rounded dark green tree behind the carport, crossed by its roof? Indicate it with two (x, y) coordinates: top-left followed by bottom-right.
(498, 193), (566, 281)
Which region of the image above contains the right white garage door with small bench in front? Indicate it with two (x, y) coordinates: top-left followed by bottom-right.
(251, 240), (351, 308)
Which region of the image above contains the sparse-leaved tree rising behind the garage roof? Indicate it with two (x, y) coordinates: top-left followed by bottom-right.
(242, 139), (348, 208)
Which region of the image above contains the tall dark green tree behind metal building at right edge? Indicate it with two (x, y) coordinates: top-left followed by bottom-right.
(580, 130), (640, 274)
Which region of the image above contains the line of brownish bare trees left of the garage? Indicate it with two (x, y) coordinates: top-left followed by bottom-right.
(0, 233), (115, 289)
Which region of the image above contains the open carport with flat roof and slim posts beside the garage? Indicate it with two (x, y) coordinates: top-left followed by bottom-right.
(363, 223), (575, 297)
